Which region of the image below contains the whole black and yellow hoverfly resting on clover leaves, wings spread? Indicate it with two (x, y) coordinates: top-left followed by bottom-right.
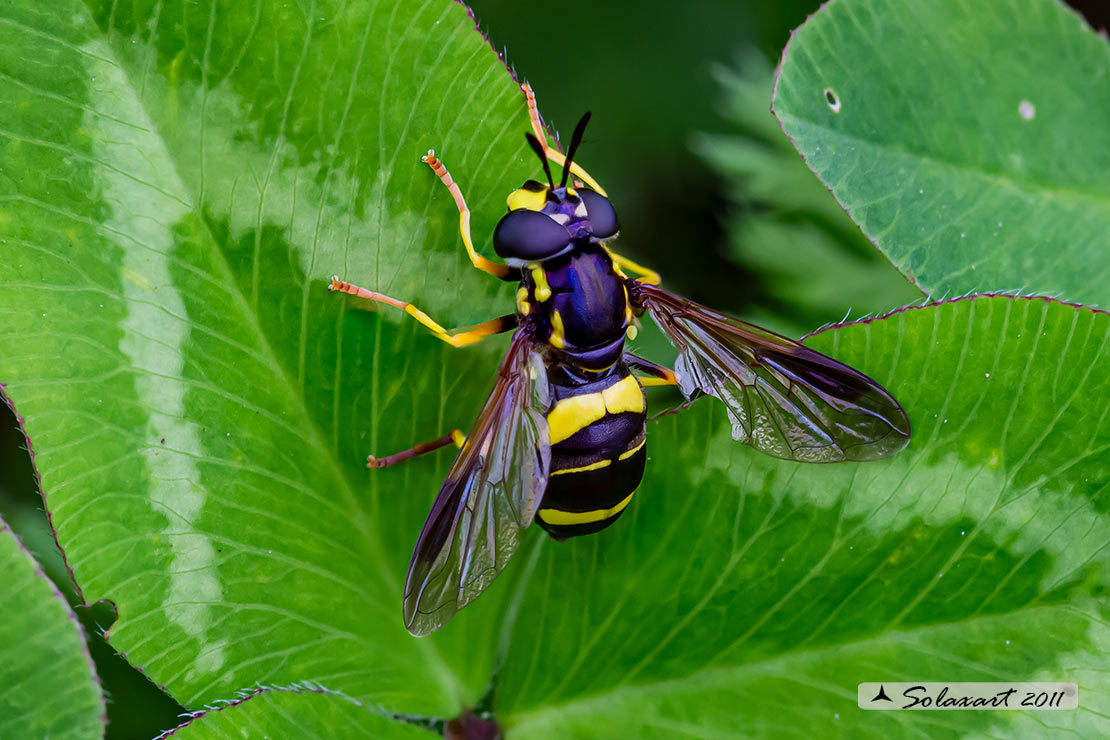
(330, 84), (910, 636)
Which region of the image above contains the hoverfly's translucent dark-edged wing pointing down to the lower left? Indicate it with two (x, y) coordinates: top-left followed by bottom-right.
(404, 331), (551, 636)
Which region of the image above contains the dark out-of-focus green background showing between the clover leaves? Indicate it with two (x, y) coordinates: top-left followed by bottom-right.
(0, 0), (1110, 740)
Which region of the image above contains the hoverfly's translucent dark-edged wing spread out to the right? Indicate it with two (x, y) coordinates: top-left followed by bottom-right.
(633, 284), (910, 463)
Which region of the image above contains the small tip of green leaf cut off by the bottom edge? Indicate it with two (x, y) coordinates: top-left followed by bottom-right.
(160, 689), (440, 740)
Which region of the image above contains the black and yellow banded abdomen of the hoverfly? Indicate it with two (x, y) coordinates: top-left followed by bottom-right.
(536, 367), (646, 539)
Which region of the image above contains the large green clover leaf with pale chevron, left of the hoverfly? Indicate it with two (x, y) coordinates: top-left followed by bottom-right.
(0, 0), (535, 717)
